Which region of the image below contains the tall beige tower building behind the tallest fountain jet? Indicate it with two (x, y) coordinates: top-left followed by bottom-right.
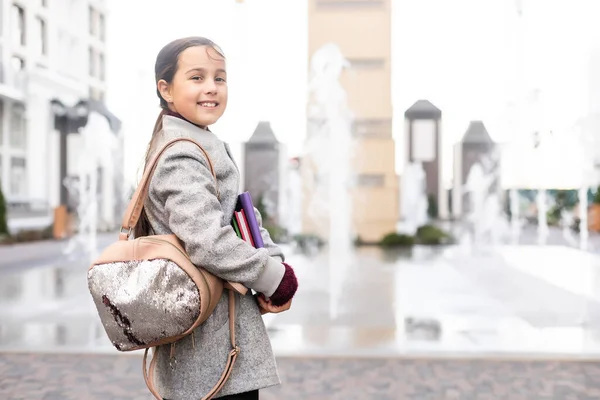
(302, 0), (399, 242)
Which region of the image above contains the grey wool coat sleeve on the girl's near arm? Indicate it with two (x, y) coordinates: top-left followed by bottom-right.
(150, 142), (285, 297)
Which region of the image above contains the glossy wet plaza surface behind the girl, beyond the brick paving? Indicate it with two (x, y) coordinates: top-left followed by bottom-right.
(0, 234), (600, 358)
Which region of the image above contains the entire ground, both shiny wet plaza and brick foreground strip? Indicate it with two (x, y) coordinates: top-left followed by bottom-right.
(0, 231), (600, 400)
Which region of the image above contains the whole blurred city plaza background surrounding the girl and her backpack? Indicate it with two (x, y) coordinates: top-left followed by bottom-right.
(0, 0), (600, 400)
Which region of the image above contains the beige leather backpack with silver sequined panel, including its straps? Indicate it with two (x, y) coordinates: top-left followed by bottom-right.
(87, 138), (247, 400)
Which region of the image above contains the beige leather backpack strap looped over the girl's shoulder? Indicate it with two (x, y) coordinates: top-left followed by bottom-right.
(119, 138), (219, 240)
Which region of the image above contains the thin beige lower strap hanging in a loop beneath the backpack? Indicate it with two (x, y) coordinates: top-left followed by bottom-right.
(142, 290), (240, 400)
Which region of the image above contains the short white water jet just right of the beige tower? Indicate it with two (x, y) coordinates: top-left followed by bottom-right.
(397, 162), (428, 235)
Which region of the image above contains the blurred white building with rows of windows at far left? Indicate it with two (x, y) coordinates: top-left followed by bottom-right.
(0, 0), (122, 229)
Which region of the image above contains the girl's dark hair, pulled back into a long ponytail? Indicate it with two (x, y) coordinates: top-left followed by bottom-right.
(133, 36), (225, 237)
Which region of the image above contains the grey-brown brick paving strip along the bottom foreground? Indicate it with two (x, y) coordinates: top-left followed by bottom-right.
(0, 355), (600, 400)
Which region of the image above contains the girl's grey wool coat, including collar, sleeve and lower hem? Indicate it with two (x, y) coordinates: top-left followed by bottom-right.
(144, 116), (285, 400)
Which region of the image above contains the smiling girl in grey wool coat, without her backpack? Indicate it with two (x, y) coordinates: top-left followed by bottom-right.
(135, 37), (298, 400)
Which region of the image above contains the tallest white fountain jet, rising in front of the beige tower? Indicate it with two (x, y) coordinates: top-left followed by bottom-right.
(306, 43), (353, 318)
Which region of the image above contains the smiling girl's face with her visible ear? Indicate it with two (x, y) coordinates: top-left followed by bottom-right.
(158, 46), (227, 127)
